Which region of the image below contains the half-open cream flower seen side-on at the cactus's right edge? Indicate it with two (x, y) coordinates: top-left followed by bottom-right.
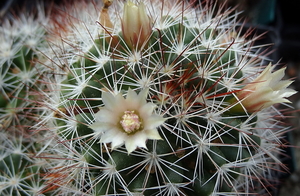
(232, 64), (296, 113)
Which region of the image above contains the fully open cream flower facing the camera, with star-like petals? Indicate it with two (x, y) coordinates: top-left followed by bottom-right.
(90, 89), (165, 154)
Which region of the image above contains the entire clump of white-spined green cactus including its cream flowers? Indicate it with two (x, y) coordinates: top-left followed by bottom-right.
(0, 0), (295, 196)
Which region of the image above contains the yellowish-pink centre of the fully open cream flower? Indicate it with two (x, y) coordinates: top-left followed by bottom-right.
(120, 111), (142, 134)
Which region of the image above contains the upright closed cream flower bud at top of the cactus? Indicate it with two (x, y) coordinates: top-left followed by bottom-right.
(122, 1), (152, 49)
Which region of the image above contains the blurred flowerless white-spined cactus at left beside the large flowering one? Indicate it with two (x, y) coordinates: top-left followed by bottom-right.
(0, 6), (48, 196)
